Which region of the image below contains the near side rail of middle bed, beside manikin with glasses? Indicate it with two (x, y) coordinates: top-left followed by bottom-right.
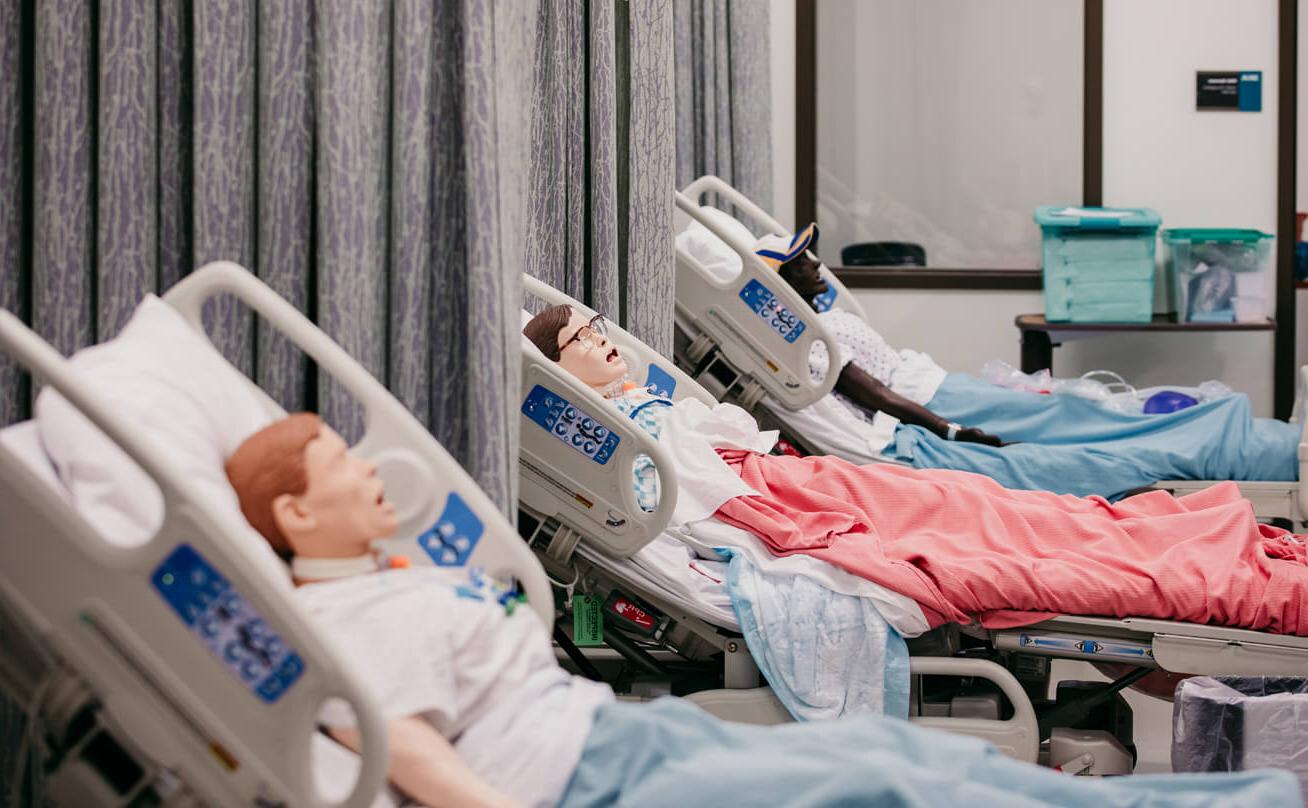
(518, 337), (678, 557)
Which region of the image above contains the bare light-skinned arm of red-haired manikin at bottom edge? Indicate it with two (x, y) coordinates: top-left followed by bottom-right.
(331, 716), (517, 808)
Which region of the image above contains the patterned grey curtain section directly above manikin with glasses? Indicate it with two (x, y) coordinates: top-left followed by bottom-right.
(526, 0), (675, 354)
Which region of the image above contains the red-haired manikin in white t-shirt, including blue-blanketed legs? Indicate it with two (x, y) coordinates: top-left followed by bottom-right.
(219, 415), (1300, 807)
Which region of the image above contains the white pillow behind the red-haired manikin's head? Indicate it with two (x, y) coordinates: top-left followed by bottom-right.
(35, 294), (286, 579)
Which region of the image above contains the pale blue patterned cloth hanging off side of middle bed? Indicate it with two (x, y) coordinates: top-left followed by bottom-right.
(719, 550), (909, 720)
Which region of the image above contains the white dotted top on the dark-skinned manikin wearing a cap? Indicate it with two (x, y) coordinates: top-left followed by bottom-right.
(808, 309), (946, 452)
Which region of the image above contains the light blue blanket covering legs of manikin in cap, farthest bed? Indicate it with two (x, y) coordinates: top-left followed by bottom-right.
(887, 374), (1299, 498)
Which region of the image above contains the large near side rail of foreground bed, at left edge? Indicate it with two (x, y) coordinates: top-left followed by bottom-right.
(0, 310), (387, 807)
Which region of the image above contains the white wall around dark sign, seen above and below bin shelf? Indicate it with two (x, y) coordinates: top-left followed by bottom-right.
(1083, 0), (1277, 414)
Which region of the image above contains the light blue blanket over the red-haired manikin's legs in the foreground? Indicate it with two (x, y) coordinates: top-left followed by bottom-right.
(559, 698), (1303, 808)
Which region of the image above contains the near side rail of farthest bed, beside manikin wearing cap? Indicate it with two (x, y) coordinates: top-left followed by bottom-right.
(676, 194), (840, 409)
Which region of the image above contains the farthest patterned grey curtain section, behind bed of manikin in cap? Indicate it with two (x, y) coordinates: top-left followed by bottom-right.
(674, 0), (772, 210)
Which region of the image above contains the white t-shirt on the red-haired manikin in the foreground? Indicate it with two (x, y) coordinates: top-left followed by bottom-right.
(296, 567), (613, 805)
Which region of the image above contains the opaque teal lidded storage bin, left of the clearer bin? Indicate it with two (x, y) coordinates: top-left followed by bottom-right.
(1035, 205), (1163, 323)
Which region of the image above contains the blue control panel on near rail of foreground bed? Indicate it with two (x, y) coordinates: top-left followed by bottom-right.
(150, 544), (305, 703)
